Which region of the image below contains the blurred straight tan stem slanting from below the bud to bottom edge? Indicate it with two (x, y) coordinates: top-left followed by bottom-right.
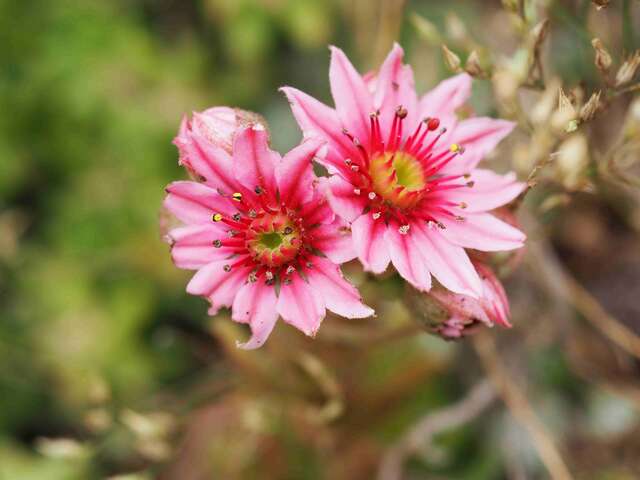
(473, 332), (573, 480)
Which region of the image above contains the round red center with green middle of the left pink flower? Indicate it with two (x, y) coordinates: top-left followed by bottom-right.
(246, 213), (302, 267)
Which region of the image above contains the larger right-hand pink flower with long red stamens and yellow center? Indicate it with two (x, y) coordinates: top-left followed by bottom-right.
(282, 45), (525, 298)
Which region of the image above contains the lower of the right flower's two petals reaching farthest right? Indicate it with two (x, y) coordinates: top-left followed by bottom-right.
(434, 213), (526, 252)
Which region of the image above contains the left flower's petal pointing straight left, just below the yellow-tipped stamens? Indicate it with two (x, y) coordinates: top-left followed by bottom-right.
(168, 224), (230, 270)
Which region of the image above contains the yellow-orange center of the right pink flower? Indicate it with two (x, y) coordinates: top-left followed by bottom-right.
(369, 151), (427, 208)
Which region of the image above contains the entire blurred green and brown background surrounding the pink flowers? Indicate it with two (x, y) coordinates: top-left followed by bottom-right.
(0, 0), (640, 480)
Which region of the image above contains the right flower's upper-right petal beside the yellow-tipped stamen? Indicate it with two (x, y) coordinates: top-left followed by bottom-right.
(447, 117), (516, 173)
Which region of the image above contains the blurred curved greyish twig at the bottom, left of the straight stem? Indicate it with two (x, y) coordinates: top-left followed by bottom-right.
(378, 380), (496, 480)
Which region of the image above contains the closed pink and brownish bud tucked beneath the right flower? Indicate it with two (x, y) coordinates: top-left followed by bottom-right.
(409, 262), (511, 340)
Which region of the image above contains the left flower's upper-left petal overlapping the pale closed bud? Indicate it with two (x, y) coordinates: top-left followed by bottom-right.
(173, 129), (236, 191)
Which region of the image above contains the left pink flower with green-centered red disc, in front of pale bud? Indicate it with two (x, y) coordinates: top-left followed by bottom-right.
(164, 122), (373, 348)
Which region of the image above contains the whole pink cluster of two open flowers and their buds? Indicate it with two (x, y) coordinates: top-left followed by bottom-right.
(165, 45), (525, 348)
